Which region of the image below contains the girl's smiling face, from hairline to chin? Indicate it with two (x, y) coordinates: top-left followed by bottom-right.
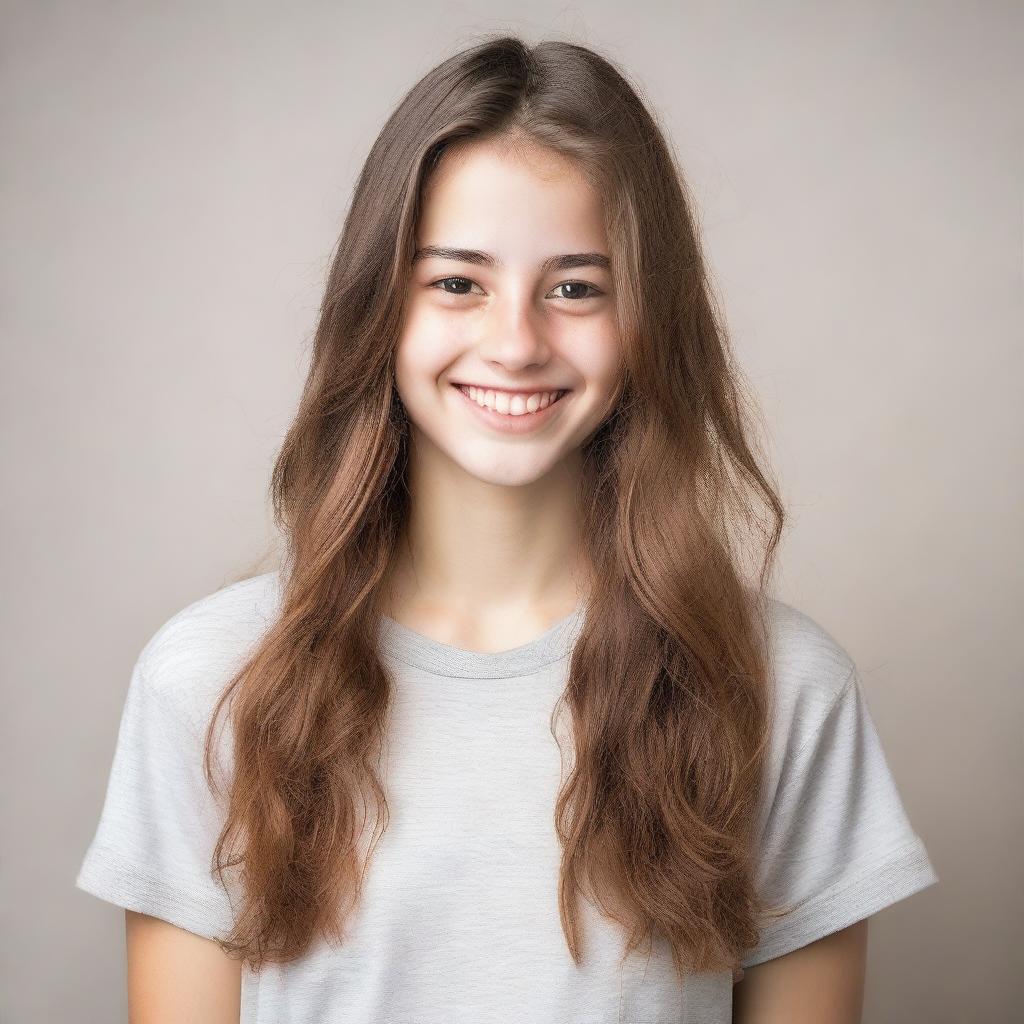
(395, 142), (622, 485)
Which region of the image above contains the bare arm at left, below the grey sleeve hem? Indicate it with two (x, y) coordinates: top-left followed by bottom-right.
(125, 910), (242, 1024)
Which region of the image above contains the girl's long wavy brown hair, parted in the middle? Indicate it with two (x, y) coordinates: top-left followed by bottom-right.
(204, 36), (783, 972)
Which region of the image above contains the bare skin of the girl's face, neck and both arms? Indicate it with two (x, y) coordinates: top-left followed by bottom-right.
(125, 143), (867, 1024)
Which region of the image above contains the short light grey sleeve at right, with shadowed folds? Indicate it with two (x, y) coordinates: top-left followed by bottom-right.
(741, 670), (938, 968)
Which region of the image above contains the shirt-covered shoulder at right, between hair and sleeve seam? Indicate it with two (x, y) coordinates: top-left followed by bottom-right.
(766, 598), (856, 758)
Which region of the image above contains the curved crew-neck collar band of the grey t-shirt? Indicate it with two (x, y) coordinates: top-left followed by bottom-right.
(379, 602), (586, 679)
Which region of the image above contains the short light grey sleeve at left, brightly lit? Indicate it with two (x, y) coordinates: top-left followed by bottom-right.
(75, 659), (232, 939)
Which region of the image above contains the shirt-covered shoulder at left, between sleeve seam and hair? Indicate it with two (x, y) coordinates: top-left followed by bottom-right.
(135, 569), (281, 722)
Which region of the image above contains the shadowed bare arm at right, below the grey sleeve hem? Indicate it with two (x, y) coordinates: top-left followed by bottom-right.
(732, 918), (867, 1024)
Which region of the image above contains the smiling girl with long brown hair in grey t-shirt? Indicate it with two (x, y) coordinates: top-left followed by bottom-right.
(76, 37), (937, 1024)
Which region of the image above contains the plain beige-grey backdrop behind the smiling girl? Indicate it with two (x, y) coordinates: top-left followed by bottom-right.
(0, 0), (1024, 1024)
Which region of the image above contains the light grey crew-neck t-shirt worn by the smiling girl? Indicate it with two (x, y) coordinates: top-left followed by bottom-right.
(75, 571), (938, 1024)
